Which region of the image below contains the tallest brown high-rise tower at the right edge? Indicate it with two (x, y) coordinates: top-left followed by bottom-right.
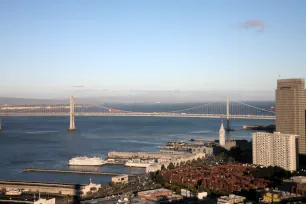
(275, 79), (306, 154)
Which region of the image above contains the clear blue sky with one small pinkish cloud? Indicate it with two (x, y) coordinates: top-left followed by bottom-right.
(0, 0), (306, 99)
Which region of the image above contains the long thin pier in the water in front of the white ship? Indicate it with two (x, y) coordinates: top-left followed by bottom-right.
(23, 168), (137, 176)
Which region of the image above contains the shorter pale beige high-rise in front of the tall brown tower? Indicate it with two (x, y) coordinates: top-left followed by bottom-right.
(252, 132), (298, 171)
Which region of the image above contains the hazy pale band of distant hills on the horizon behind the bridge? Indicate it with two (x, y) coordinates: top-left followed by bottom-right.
(0, 90), (274, 105)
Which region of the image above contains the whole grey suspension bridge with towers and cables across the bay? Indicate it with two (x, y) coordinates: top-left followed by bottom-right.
(0, 96), (275, 130)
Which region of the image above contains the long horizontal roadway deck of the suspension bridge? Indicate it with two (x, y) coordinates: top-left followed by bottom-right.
(0, 112), (275, 120)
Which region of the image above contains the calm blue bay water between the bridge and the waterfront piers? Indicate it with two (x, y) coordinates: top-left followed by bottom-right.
(0, 111), (274, 183)
